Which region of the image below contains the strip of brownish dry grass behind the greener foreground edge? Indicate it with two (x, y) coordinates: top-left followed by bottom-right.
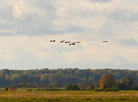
(0, 91), (138, 98)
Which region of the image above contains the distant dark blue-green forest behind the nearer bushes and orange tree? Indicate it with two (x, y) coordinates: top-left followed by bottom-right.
(0, 68), (138, 87)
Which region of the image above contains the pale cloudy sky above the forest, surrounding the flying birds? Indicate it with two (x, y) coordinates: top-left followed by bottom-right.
(0, 0), (138, 70)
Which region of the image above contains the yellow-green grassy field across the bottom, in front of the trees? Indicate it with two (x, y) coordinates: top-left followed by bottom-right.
(0, 91), (138, 102)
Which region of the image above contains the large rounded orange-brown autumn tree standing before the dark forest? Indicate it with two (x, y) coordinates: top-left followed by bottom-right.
(100, 74), (116, 89)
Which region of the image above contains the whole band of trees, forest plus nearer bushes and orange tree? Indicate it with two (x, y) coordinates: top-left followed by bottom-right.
(0, 68), (138, 90)
